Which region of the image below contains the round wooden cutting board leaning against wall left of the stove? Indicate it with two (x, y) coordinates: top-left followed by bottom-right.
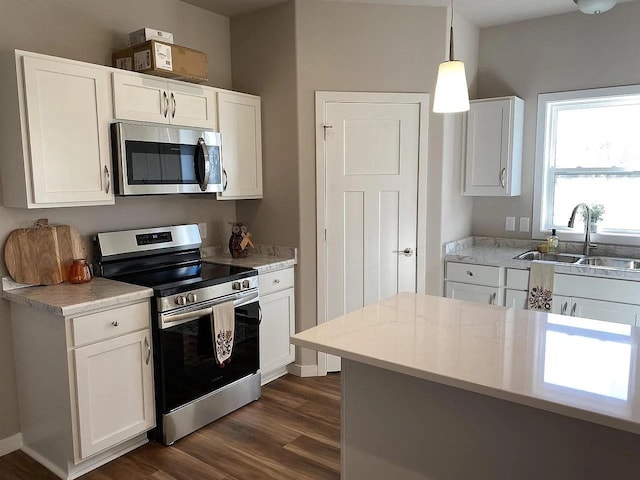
(4, 220), (87, 285)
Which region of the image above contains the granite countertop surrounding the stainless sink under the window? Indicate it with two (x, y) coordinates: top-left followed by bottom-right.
(443, 237), (640, 281)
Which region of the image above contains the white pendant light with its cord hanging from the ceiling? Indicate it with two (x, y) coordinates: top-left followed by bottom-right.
(433, 0), (469, 113)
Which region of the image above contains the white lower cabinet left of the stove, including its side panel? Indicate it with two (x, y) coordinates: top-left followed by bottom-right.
(11, 299), (155, 479)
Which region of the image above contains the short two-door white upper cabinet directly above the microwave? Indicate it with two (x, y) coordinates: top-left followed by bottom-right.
(113, 72), (218, 130)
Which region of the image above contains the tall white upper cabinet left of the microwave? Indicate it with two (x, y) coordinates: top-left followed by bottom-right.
(0, 51), (114, 208)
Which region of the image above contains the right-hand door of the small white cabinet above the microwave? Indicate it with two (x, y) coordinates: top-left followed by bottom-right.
(168, 83), (218, 130)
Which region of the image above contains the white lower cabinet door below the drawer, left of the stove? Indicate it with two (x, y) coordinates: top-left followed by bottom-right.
(73, 329), (155, 459)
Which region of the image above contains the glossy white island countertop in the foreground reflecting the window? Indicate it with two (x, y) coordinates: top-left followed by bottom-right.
(291, 293), (640, 434)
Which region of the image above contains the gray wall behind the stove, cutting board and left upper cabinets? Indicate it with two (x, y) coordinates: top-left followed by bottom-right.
(0, 0), (235, 440)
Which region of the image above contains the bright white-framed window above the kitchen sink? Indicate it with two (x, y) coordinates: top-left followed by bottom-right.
(534, 85), (640, 244)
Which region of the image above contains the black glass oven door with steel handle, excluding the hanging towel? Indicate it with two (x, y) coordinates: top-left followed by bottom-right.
(156, 291), (260, 414)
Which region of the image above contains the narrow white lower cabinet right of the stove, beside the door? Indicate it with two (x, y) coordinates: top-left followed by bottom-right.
(259, 268), (295, 385)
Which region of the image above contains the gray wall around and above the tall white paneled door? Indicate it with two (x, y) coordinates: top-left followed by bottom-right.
(296, 0), (447, 365)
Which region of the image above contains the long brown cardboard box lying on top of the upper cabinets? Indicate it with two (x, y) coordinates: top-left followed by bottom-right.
(113, 40), (209, 83)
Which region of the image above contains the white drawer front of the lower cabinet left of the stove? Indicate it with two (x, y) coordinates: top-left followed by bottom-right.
(71, 300), (151, 347)
